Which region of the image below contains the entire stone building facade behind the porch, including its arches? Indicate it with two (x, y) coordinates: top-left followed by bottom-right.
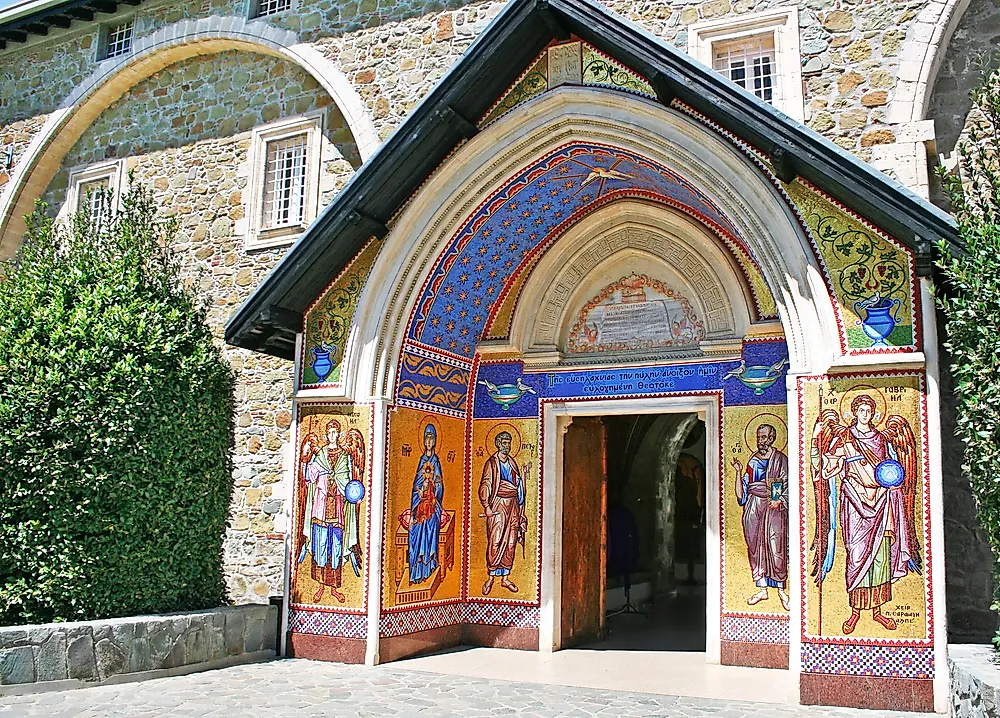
(0, 0), (998, 633)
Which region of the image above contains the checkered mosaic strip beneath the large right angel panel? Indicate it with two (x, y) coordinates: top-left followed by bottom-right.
(802, 641), (934, 678)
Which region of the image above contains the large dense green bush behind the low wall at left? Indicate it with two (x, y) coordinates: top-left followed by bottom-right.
(0, 183), (234, 624)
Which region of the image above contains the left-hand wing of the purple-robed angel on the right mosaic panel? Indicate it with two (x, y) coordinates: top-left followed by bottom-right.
(809, 409), (847, 584)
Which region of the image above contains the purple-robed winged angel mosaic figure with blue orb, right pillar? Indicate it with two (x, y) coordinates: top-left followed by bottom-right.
(811, 392), (921, 635)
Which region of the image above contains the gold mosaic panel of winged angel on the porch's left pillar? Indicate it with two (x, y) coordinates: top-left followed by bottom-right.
(291, 404), (372, 613)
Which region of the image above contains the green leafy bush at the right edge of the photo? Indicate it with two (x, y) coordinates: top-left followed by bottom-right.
(939, 62), (1000, 643)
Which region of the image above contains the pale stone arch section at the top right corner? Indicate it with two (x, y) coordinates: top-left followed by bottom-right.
(887, 0), (971, 124)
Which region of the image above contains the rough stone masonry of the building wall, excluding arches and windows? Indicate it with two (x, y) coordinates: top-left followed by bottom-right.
(0, 0), (972, 601)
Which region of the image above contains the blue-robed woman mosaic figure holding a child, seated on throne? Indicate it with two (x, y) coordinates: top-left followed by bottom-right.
(407, 424), (444, 583)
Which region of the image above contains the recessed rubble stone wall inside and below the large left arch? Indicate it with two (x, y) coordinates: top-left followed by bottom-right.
(46, 51), (359, 602)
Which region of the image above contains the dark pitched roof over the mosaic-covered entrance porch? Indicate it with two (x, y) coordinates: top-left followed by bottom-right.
(225, 0), (961, 359)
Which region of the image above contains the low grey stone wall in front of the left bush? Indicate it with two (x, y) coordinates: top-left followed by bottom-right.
(0, 604), (278, 696)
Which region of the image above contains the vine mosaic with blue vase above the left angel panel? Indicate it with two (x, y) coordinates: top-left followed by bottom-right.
(300, 240), (381, 386)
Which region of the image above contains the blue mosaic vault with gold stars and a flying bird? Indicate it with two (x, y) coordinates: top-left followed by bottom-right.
(408, 143), (754, 358)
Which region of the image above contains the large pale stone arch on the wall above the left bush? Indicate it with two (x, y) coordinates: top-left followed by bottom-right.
(0, 15), (379, 258)
